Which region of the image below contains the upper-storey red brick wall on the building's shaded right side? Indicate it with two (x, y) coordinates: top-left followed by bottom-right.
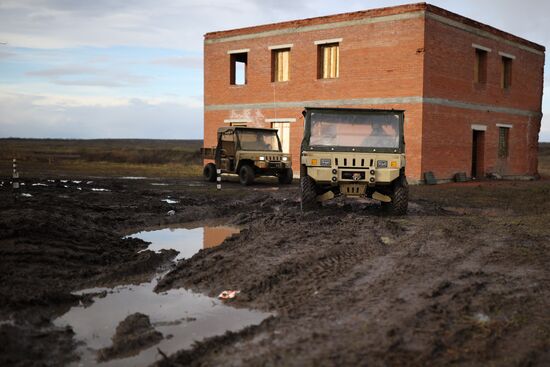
(424, 18), (544, 110)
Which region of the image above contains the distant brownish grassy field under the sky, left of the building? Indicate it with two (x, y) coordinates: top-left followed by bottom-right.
(0, 139), (202, 177)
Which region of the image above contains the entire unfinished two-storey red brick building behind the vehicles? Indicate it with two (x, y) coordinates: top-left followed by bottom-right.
(204, 3), (545, 182)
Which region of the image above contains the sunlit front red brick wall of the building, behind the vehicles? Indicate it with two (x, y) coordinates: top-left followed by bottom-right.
(204, 18), (424, 177)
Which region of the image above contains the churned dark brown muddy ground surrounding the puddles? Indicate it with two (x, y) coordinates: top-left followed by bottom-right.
(0, 178), (550, 366)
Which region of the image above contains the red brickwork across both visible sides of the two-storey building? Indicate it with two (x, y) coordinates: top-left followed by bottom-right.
(204, 5), (544, 180)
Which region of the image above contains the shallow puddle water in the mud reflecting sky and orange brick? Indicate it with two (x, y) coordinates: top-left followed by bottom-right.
(54, 226), (270, 366)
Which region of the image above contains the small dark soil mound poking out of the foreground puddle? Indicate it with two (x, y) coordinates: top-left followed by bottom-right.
(98, 313), (163, 362)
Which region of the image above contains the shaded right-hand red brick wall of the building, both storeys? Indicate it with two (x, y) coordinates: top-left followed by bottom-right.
(422, 18), (544, 179)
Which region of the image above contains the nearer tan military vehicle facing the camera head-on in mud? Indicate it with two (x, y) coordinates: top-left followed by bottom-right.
(300, 108), (409, 215)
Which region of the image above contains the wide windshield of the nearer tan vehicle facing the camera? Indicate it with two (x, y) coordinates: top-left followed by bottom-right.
(309, 112), (399, 149)
